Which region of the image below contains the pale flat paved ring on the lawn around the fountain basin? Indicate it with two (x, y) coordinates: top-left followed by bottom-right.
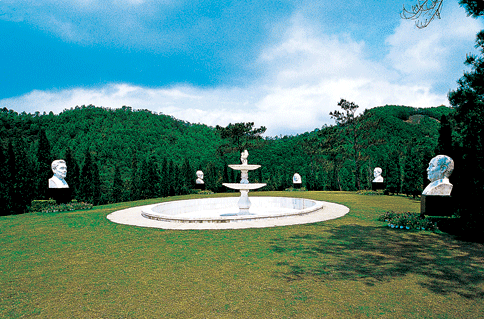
(107, 201), (349, 230)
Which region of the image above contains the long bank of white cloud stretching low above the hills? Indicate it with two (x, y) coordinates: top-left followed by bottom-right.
(0, 5), (482, 135)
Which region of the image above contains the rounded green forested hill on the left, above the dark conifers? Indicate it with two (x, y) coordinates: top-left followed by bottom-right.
(0, 105), (220, 167)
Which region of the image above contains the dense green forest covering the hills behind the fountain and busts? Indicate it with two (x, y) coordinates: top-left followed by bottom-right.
(0, 105), (454, 214)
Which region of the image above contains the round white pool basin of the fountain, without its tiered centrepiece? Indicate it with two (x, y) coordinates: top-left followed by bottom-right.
(141, 196), (323, 223)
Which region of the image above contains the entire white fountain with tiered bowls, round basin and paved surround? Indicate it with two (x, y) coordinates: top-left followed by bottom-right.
(108, 150), (349, 229)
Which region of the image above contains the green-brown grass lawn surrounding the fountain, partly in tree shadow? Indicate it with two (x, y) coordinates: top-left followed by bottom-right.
(0, 192), (484, 318)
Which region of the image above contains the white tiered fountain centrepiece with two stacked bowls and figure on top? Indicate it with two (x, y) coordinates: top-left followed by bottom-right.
(220, 150), (266, 216)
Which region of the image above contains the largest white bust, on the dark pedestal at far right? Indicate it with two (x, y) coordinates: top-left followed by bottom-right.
(422, 155), (454, 196)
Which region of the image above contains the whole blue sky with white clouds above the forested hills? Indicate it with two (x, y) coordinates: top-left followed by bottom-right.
(0, 0), (484, 136)
